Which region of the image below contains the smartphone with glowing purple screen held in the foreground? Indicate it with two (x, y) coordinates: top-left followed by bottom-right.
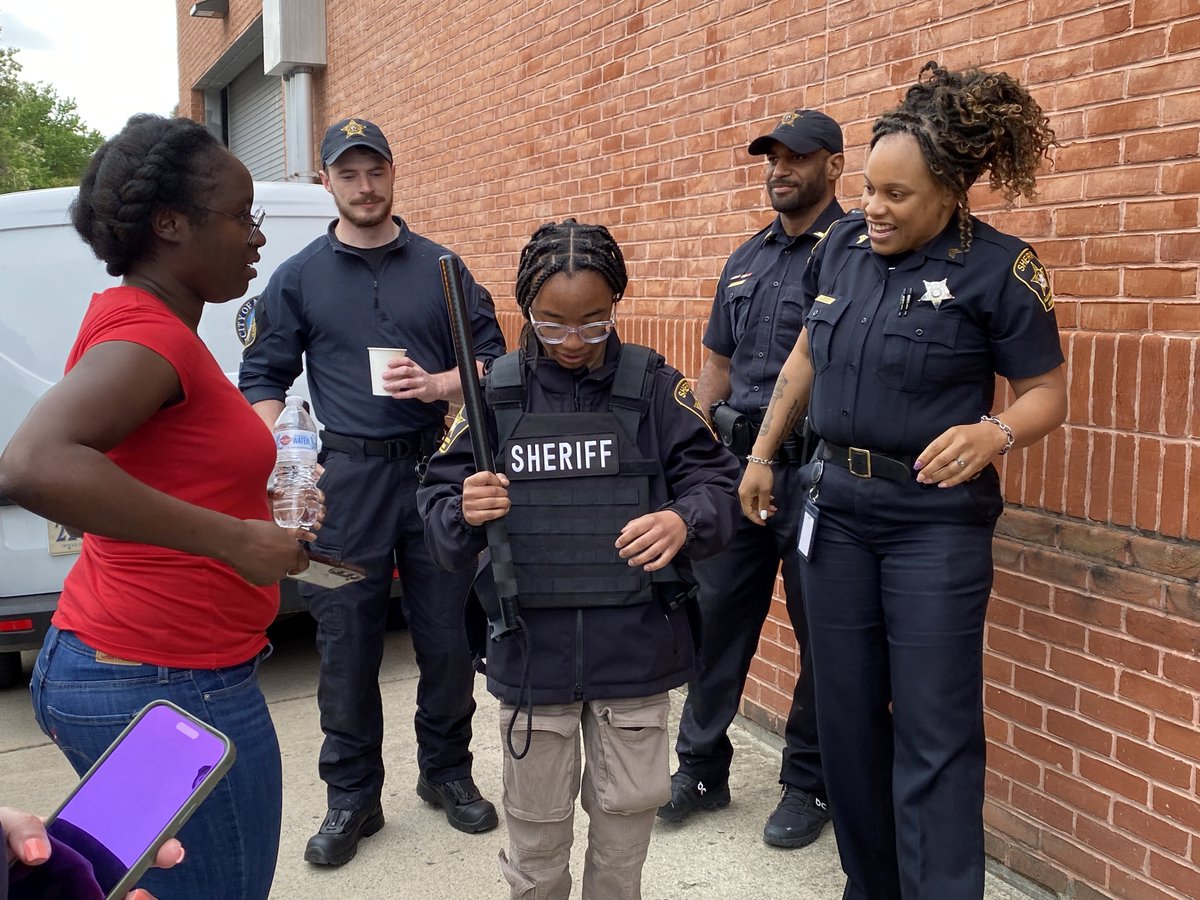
(49, 706), (224, 894)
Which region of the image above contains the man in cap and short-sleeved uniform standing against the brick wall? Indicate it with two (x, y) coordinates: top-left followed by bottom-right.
(659, 109), (845, 847)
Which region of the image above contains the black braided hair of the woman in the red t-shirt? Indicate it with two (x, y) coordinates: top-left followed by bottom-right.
(71, 113), (221, 276)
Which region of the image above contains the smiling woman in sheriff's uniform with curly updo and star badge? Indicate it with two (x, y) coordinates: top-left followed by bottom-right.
(739, 62), (1067, 900)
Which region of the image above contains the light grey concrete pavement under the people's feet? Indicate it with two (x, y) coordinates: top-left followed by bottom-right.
(0, 617), (1026, 900)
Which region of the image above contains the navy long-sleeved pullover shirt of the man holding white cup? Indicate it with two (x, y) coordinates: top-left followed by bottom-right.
(238, 216), (504, 440)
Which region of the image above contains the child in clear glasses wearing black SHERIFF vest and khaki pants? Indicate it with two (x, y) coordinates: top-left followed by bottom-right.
(419, 220), (738, 900)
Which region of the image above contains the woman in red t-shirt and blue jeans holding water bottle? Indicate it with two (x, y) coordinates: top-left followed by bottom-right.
(0, 115), (314, 900)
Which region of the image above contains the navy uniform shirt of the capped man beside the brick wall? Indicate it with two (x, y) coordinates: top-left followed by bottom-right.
(704, 200), (842, 415)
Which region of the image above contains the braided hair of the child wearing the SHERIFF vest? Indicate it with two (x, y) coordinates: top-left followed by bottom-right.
(516, 218), (629, 349)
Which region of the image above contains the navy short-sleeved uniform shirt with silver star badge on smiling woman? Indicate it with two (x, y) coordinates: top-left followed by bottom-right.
(804, 210), (1063, 454)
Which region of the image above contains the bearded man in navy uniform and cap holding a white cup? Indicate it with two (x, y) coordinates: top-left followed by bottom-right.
(239, 118), (504, 865)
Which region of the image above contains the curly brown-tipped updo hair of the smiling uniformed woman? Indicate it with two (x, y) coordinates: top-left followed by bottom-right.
(871, 62), (1055, 252)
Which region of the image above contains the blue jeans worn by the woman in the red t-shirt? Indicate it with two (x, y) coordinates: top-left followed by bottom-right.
(30, 628), (283, 900)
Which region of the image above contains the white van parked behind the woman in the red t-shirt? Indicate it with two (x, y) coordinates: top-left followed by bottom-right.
(0, 181), (337, 688)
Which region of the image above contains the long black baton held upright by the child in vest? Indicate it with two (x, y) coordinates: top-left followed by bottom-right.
(438, 254), (517, 640)
